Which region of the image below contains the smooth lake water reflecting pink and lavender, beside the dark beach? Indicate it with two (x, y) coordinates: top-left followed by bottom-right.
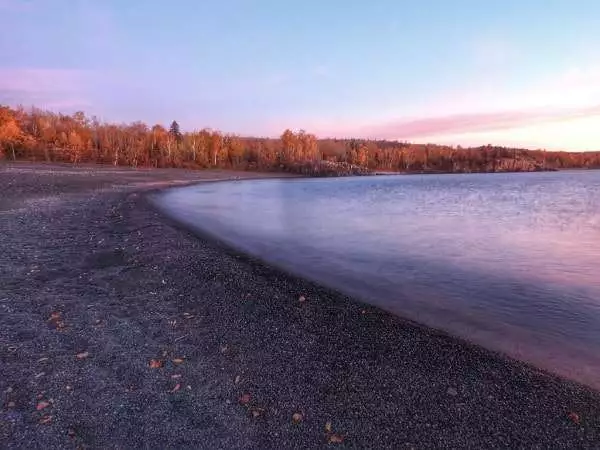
(156, 171), (600, 387)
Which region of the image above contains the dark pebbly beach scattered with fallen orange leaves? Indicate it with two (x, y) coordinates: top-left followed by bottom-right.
(0, 164), (600, 449)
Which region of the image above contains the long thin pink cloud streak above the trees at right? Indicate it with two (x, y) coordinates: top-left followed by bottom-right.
(357, 105), (600, 140)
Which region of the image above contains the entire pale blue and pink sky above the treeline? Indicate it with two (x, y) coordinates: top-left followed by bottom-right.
(0, 0), (600, 151)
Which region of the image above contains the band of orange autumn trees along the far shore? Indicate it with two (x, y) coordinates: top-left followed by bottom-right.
(0, 106), (600, 175)
